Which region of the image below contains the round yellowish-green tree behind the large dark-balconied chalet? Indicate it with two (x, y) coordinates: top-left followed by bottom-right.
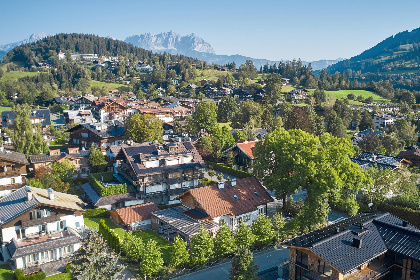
(124, 114), (163, 143)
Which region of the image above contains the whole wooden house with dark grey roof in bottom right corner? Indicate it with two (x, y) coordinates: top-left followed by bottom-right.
(282, 213), (420, 280)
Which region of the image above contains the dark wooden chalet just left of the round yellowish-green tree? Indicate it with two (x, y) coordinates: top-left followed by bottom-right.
(67, 123), (124, 152)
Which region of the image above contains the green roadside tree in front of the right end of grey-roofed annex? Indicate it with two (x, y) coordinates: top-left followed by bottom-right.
(190, 227), (214, 265)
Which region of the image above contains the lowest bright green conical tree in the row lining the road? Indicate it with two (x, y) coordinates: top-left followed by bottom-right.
(140, 239), (163, 277)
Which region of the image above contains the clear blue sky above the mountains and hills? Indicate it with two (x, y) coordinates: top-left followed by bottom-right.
(0, 0), (420, 61)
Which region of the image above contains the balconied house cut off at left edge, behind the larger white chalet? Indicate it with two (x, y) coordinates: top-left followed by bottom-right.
(0, 149), (29, 197)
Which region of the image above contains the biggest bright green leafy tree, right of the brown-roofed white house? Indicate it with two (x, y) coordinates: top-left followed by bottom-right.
(254, 129), (370, 229)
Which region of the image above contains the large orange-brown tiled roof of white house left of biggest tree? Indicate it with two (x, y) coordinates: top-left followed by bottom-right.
(179, 177), (273, 218)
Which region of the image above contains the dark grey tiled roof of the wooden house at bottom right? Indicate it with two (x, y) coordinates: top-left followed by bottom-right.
(284, 213), (420, 274)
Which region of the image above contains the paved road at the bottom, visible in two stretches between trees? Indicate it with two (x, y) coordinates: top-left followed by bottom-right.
(173, 248), (289, 280)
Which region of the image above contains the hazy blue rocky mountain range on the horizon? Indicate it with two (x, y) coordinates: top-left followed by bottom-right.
(124, 31), (344, 70)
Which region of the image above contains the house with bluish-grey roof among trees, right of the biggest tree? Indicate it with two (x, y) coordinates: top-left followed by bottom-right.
(350, 152), (410, 171)
